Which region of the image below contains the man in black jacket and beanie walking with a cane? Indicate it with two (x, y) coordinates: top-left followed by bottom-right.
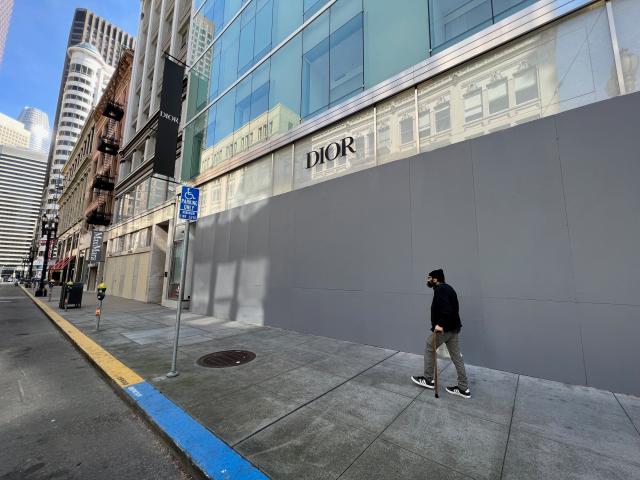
(411, 269), (471, 398)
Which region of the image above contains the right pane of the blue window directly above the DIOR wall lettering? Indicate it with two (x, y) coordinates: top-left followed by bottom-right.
(329, 13), (364, 104)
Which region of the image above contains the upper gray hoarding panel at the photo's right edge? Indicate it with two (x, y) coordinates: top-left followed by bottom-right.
(557, 94), (640, 305)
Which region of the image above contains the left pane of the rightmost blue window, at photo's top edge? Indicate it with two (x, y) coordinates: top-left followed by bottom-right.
(429, 0), (493, 50)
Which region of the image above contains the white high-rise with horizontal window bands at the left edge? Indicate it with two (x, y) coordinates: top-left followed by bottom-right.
(0, 145), (47, 274)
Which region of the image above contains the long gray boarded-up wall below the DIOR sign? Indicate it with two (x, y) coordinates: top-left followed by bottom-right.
(192, 94), (640, 394)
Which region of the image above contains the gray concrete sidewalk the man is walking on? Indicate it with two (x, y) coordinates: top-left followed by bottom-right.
(45, 295), (640, 480)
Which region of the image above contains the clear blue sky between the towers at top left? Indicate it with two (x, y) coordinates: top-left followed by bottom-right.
(0, 0), (140, 126)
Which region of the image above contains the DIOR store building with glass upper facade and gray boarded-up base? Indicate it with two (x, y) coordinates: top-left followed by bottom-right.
(178, 0), (640, 393)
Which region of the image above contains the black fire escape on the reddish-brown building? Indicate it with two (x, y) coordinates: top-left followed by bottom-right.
(85, 100), (124, 225)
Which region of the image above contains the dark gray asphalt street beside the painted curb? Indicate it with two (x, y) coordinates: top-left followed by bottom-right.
(0, 284), (191, 480)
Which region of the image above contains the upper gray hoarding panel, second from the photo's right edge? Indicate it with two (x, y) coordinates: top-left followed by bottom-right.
(471, 118), (574, 300)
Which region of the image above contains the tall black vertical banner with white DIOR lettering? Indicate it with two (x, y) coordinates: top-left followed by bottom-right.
(153, 57), (184, 177)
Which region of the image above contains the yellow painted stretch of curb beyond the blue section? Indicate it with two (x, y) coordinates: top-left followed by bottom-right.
(21, 286), (144, 388)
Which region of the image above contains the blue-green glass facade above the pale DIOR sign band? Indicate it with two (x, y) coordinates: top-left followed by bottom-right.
(182, 0), (544, 179)
